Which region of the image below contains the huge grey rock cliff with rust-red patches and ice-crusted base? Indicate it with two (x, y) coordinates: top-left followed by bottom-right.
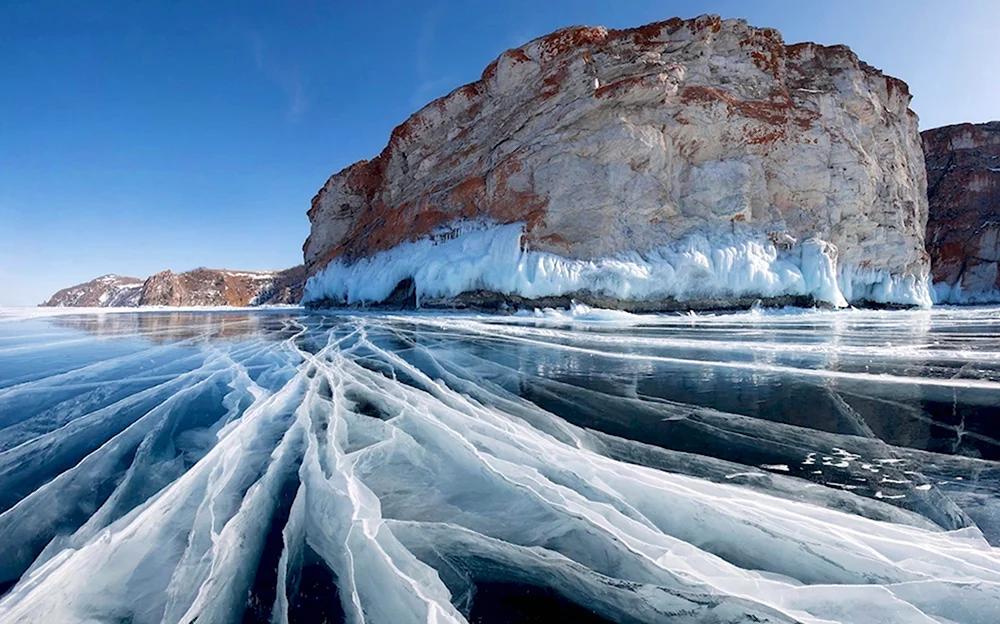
(303, 16), (929, 304)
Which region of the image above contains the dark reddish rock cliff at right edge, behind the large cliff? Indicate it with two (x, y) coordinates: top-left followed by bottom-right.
(921, 121), (1000, 303)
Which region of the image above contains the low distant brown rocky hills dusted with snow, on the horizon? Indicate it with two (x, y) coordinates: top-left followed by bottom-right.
(42, 265), (305, 307)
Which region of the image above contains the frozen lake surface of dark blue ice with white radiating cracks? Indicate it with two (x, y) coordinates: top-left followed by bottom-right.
(0, 307), (1000, 624)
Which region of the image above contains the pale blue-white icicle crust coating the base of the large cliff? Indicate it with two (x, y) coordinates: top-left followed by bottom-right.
(304, 224), (930, 307)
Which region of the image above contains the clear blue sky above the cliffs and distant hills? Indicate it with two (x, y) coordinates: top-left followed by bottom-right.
(0, 0), (1000, 305)
